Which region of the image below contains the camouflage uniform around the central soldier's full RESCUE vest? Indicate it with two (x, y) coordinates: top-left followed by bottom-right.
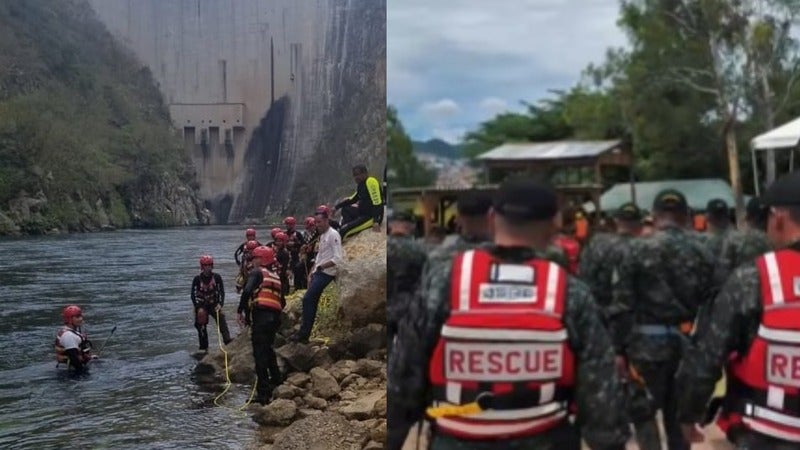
(387, 245), (628, 450)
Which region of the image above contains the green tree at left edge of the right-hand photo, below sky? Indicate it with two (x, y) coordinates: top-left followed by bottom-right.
(386, 105), (436, 187)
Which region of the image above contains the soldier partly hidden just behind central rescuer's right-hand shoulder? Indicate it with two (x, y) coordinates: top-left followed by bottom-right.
(579, 202), (642, 310)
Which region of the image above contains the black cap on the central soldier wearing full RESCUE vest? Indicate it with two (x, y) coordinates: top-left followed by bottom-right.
(493, 178), (558, 222)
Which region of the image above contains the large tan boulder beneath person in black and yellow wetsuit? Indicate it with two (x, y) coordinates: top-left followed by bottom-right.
(336, 230), (386, 329)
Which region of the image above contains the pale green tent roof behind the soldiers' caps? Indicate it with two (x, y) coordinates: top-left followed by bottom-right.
(600, 178), (736, 212)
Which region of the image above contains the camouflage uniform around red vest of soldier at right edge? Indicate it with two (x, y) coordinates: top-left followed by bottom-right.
(675, 243), (800, 450)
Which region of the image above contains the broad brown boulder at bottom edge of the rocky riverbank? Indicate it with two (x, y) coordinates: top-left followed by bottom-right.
(272, 412), (370, 450)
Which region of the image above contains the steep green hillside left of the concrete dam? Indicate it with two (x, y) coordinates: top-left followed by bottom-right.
(0, 0), (199, 234)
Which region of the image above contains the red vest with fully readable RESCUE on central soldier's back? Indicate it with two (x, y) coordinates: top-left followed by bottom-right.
(429, 250), (575, 440)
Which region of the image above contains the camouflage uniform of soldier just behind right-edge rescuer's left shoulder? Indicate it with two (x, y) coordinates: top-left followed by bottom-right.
(713, 228), (771, 290)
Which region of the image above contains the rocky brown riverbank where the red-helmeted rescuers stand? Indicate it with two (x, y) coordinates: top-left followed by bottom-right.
(200, 231), (386, 450)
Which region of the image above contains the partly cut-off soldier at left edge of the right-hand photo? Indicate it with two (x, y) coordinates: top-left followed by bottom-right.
(386, 212), (428, 358)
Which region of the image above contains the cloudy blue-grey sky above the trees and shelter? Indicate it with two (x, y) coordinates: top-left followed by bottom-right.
(387, 0), (625, 142)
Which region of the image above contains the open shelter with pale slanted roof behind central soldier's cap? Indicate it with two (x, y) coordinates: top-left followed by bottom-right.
(477, 140), (633, 214)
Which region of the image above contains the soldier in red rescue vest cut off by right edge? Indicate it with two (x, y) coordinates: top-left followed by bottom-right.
(676, 172), (800, 450)
